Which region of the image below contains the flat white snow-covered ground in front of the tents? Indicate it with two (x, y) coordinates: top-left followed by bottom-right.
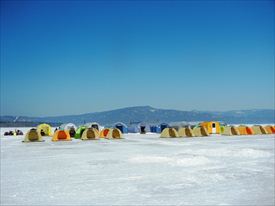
(1, 128), (275, 205)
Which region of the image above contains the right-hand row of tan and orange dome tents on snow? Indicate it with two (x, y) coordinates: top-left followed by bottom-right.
(160, 123), (275, 138)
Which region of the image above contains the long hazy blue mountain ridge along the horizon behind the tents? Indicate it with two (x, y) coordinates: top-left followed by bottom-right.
(0, 106), (275, 125)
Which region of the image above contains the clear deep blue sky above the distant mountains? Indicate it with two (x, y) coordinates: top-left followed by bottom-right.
(1, 0), (275, 116)
